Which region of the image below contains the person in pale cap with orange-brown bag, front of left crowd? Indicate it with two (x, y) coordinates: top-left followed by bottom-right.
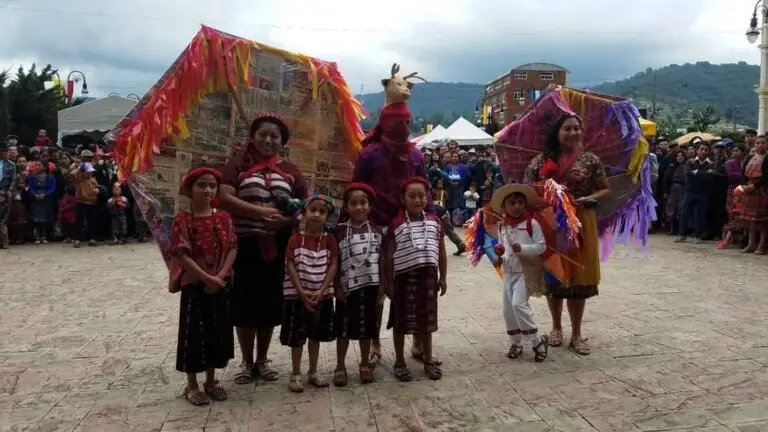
(70, 162), (99, 248)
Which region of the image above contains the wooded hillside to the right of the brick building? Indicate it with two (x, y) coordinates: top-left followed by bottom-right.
(591, 62), (760, 125)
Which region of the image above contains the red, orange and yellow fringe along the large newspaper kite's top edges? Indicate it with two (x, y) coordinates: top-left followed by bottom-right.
(115, 26), (366, 179)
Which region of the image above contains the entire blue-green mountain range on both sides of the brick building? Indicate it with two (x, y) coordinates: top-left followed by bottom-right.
(360, 62), (760, 127)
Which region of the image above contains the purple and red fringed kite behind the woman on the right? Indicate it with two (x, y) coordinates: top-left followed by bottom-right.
(495, 86), (656, 260)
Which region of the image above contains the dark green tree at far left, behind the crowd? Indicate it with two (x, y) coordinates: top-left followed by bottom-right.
(5, 64), (68, 145)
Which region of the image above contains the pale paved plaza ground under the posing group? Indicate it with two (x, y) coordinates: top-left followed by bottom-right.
(0, 236), (768, 432)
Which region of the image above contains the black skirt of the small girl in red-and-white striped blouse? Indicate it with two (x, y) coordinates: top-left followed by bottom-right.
(280, 298), (336, 348)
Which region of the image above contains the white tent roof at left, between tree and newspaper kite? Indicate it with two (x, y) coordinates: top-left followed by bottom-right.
(58, 95), (136, 143)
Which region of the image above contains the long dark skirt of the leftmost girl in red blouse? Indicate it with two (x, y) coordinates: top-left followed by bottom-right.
(176, 283), (235, 373)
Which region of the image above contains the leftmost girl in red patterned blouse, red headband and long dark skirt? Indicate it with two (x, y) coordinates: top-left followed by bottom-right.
(168, 167), (237, 405)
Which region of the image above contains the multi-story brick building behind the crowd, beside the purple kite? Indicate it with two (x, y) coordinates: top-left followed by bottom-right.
(483, 63), (569, 124)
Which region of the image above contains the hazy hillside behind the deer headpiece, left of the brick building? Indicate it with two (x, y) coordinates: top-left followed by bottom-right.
(362, 82), (485, 130)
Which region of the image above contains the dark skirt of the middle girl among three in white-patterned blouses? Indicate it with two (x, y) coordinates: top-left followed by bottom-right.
(336, 285), (379, 340)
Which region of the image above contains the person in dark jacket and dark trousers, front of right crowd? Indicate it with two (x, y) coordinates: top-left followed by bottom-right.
(675, 141), (715, 243)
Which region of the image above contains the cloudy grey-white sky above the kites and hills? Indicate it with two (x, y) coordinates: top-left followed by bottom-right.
(0, 0), (760, 95)
